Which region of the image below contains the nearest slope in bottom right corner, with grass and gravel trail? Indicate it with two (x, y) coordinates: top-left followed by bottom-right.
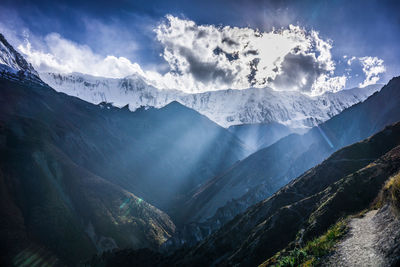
(268, 164), (400, 267)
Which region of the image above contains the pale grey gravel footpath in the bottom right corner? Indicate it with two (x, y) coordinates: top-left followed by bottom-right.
(323, 210), (386, 267)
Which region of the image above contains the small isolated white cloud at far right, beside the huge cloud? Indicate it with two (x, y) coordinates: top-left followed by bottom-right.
(359, 57), (386, 87)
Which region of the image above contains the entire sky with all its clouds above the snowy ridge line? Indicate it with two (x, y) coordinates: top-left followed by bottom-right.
(0, 0), (400, 95)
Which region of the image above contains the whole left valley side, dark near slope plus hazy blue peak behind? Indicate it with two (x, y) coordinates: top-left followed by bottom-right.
(0, 35), (247, 265)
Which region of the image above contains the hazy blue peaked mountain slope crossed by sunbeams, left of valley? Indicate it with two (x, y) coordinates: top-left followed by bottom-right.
(0, 69), (247, 218)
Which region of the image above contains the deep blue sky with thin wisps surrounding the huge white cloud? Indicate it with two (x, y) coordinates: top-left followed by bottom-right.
(0, 0), (400, 90)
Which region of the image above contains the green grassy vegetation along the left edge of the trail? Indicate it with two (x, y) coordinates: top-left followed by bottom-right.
(260, 220), (347, 267)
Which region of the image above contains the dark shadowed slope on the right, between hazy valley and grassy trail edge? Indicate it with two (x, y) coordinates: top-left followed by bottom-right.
(90, 123), (400, 266)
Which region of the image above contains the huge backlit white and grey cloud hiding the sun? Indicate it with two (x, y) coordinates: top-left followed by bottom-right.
(155, 15), (346, 94)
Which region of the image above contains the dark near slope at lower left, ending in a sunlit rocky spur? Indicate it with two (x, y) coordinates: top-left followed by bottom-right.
(0, 79), (175, 264)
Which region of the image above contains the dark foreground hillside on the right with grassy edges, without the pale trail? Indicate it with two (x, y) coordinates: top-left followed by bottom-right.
(111, 123), (400, 266)
